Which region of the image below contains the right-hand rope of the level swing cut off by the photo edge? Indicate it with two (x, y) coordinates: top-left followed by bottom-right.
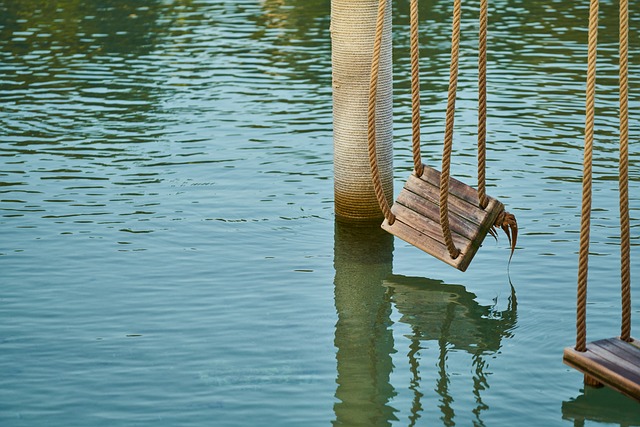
(619, 0), (631, 341)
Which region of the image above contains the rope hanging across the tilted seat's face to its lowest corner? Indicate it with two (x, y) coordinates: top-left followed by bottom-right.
(440, 0), (462, 259)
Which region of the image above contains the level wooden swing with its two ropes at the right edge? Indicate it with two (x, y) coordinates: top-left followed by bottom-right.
(563, 0), (640, 402)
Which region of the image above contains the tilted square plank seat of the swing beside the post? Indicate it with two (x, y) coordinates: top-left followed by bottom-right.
(382, 166), (504, 271)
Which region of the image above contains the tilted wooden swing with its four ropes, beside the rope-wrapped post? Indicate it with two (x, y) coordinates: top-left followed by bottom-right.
(368, 0), (518, 271)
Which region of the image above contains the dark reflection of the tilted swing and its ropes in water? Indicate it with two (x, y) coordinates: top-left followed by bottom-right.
(383, 275), (517, 425)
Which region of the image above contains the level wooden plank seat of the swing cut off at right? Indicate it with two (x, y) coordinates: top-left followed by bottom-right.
(563, 338), (640, 402)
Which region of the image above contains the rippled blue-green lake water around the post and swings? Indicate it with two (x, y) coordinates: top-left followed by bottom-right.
(0, 0), (640, 427)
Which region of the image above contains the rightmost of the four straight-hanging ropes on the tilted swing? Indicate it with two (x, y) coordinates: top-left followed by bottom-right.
(478, 0), (489, 209)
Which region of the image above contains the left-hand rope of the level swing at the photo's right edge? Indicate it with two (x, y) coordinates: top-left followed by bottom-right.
(575, 0), (599, 351)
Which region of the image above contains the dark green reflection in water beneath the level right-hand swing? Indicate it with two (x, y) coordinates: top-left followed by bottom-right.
(562, 387), (640, 427)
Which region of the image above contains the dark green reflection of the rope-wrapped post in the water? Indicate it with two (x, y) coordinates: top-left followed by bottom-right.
(334, 222), (397, 426)
